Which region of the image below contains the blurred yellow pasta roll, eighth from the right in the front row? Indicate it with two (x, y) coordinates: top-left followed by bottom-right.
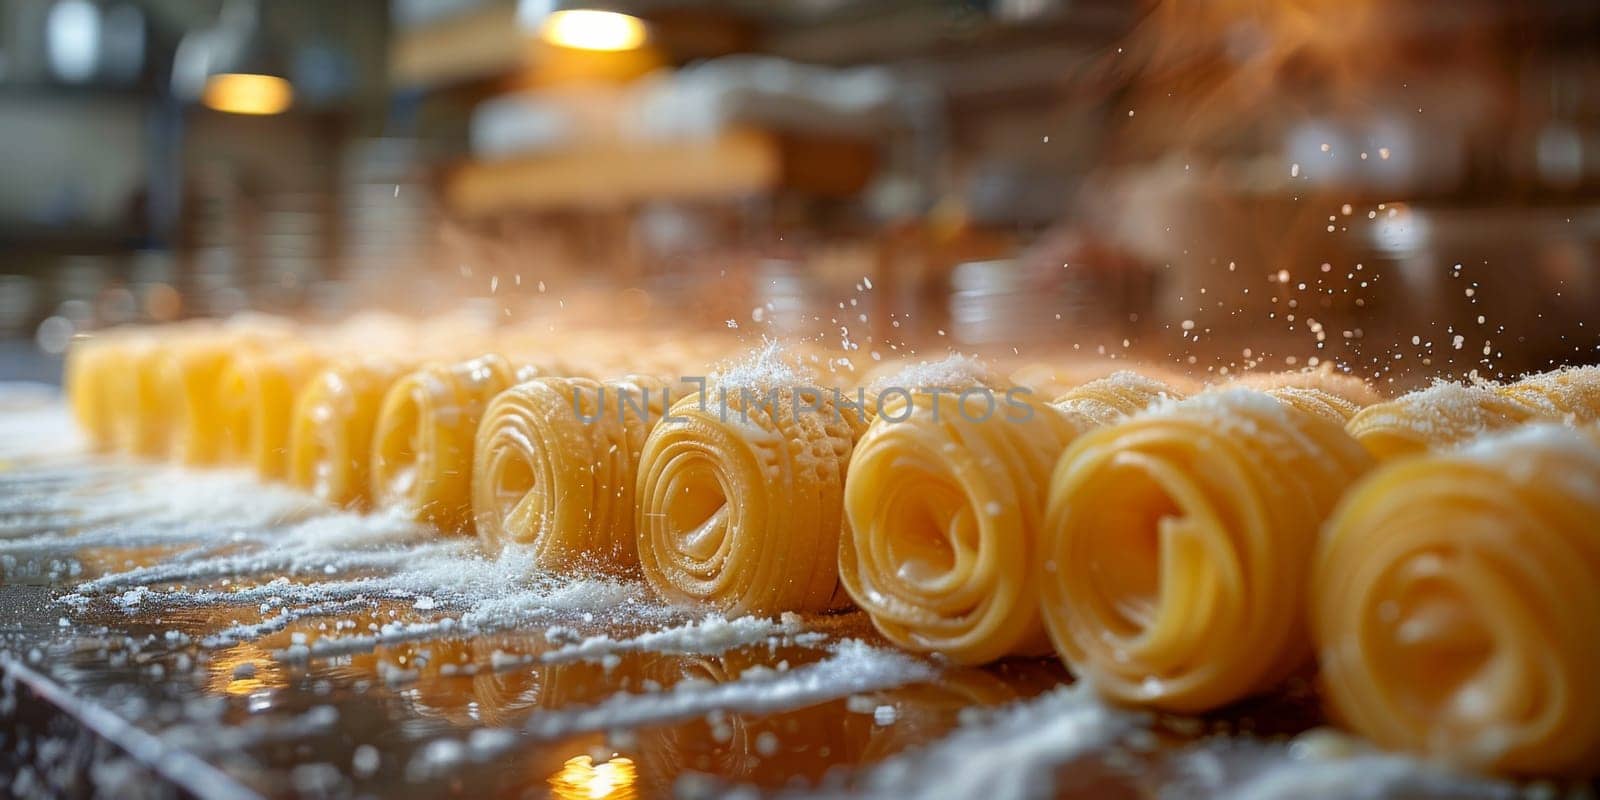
(216, 342), (323, 480)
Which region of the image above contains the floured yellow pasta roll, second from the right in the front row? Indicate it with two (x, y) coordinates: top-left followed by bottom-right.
(1040, 389), (1371, 712)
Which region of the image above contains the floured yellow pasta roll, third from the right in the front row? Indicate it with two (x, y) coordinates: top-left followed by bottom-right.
(838, 373), (1170, 664)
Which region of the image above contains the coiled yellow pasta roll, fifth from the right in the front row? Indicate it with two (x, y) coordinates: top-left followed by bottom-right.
(472, 376), (683, 573)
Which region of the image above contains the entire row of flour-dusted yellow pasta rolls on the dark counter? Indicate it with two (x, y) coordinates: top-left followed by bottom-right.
(67, 317), (1600, 774)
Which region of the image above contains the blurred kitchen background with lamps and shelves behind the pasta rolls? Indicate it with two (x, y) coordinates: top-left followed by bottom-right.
(0, 0), (1600, 384)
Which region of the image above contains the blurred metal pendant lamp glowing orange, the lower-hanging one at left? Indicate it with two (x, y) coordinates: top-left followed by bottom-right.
(173, 0), (294, 115)
